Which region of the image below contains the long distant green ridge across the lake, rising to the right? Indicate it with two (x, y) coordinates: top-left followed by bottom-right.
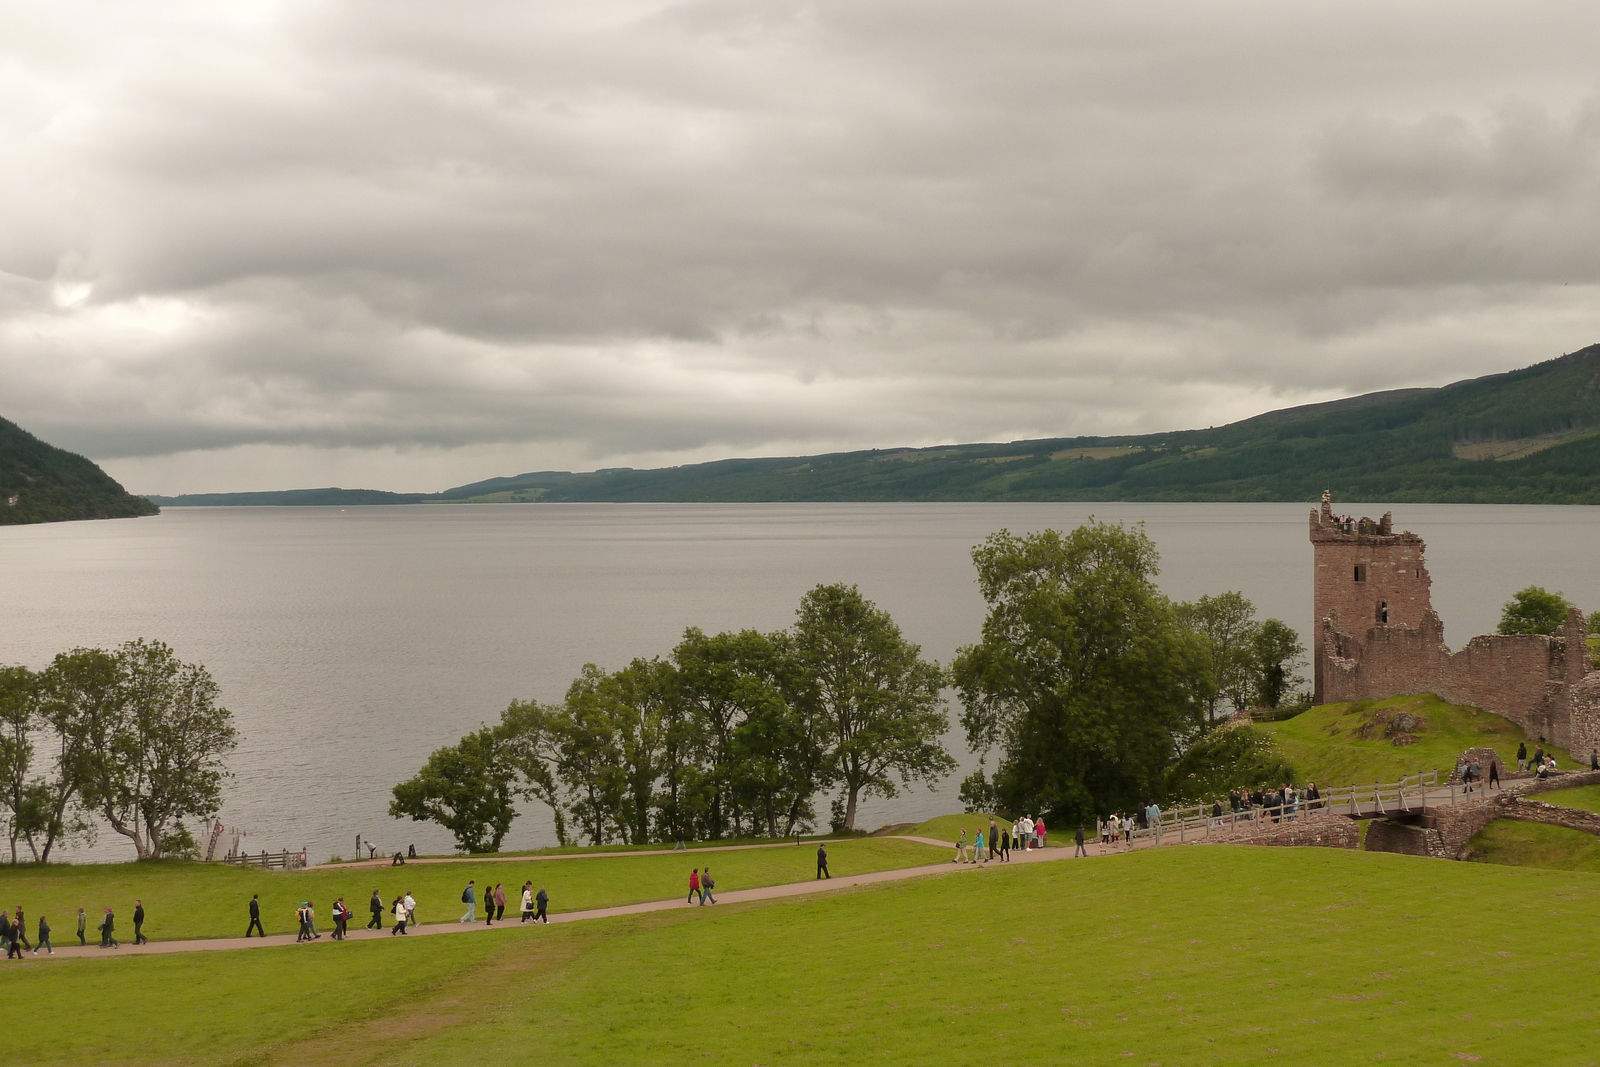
(150, 346), (1600, 506)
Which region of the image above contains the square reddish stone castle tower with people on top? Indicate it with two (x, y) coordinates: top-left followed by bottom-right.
(1310, 493), (1434, 704)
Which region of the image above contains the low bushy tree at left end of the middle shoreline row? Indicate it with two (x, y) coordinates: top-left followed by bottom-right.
(389, 726), (517, 853)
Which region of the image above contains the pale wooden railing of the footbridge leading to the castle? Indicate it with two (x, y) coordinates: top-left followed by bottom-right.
(1107, 769), (1466, 845)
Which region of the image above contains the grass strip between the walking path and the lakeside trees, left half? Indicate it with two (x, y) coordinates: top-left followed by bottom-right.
(5, 838), (947, 944)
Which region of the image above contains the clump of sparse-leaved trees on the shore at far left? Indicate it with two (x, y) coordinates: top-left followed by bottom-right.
(0, 640), (237, 862)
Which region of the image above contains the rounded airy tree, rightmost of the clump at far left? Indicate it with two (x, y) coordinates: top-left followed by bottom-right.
(74, 640), (238, 859)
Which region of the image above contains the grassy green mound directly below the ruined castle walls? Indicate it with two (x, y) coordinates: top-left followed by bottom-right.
(1258, 693), (1573, 787)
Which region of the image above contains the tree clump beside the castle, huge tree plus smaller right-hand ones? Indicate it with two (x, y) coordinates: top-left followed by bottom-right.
(954, 520), (1304, 824)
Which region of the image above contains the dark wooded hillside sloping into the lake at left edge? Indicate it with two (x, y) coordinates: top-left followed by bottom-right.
(0, 419), (158, 526)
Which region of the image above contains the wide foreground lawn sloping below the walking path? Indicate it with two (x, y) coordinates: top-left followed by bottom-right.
(0, 846), (1600, 1067)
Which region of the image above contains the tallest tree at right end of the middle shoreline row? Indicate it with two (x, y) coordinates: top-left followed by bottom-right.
(794, 584), (955, 829)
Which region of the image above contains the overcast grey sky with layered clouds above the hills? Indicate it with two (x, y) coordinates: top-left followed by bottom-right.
(0, 0), (1600, 493)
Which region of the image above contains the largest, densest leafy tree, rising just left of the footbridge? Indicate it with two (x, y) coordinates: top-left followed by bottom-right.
(954, 520), (1206, 824)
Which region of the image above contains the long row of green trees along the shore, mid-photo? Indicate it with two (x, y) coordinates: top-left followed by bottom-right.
(389, 584), (955, 853)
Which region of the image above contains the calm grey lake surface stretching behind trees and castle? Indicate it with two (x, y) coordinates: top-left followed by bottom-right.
(0, 502), (1600, 862)
